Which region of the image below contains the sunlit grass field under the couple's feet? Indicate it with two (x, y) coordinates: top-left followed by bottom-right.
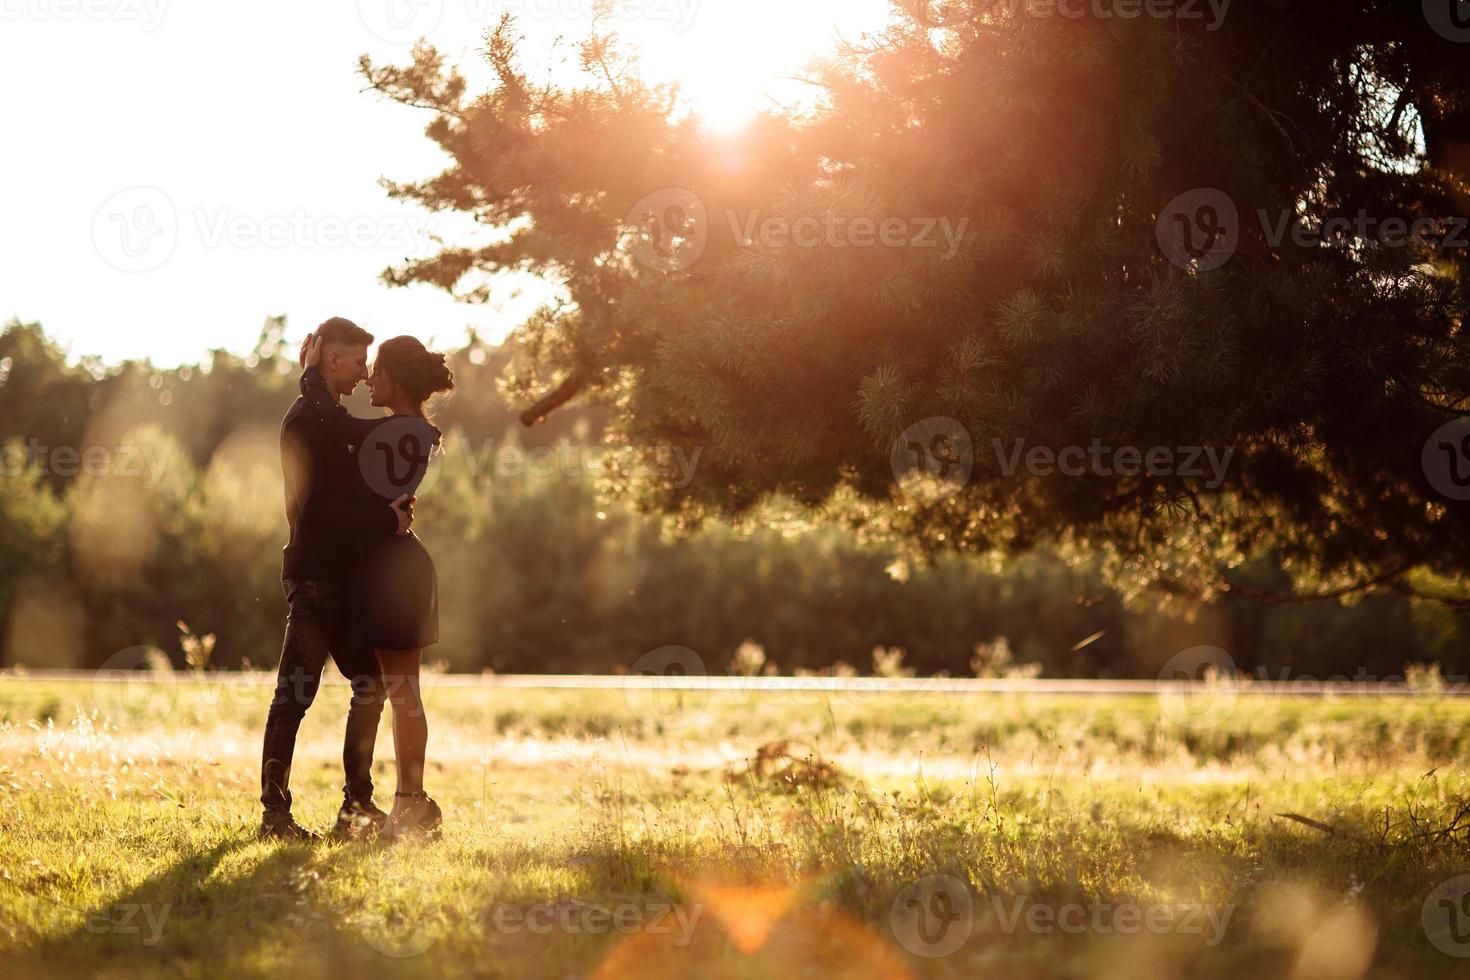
(0, 679), (1470, 980)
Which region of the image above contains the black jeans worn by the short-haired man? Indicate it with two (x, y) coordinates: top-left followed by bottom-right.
(260, 580), (385, 813)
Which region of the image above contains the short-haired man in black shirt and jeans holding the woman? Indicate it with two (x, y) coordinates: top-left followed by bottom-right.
(260, 317), (413, 840)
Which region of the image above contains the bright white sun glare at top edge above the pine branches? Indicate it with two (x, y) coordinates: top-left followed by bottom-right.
(616, 0), (888, 132)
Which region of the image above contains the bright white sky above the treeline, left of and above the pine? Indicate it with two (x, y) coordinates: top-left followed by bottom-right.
(0, 0), (886, 364)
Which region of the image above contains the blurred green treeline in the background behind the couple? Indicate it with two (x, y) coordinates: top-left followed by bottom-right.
(0, 320), (1470, 679)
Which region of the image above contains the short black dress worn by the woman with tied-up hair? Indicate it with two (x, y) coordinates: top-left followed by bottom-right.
(301, 367), (441, 649)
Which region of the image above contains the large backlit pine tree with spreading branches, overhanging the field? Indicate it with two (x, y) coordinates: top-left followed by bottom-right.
(362, 0), (1470, 605)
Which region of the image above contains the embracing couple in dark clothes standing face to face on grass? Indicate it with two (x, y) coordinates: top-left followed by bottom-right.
(260, 317), (454, 840)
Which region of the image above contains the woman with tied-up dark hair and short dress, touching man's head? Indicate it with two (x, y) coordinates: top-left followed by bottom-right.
(301, 336), (454, 840)
